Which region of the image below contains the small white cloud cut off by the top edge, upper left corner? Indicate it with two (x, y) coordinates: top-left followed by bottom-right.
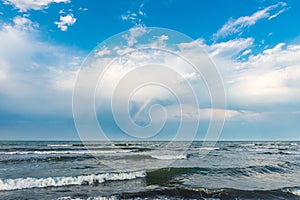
(3, 0), (71, 12)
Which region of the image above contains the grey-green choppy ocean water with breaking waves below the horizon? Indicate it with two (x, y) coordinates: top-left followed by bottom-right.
(0, 141), (300, 200)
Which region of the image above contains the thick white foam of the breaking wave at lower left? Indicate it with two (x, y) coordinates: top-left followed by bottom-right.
(0, 171), (146, 190)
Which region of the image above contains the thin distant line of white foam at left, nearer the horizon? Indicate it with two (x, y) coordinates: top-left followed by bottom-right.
(0, 149), (133, 155)
